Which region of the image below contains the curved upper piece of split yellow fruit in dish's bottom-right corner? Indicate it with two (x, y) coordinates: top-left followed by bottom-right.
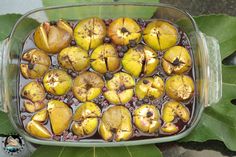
(162, 101), (190, 122)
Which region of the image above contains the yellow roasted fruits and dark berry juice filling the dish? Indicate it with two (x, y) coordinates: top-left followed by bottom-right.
(19, 17), (195, 142)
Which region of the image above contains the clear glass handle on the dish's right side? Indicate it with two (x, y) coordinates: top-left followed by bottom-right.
(199, 32), (222, 107)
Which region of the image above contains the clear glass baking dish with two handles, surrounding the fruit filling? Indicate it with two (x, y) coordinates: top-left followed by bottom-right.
(0, 2), (222, 147)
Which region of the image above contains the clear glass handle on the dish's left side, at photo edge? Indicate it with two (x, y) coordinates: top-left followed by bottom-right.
(0, 38), (9, 112)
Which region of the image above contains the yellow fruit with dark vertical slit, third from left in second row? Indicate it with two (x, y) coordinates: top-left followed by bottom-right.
(90, 44), (120, 74)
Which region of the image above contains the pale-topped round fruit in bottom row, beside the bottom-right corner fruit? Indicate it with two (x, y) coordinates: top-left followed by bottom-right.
(133, 104), (161, 134)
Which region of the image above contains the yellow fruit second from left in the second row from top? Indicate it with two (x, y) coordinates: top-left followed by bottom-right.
(57, 46), (89, 72)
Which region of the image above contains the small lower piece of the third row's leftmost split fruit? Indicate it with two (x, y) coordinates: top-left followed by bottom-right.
(24, 100), (46, 113)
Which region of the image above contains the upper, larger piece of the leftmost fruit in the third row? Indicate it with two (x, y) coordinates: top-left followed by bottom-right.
(21, 81), (45, 102)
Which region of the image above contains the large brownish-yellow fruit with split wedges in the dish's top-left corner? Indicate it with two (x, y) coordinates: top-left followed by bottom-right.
(34, 20), (73, 54)
